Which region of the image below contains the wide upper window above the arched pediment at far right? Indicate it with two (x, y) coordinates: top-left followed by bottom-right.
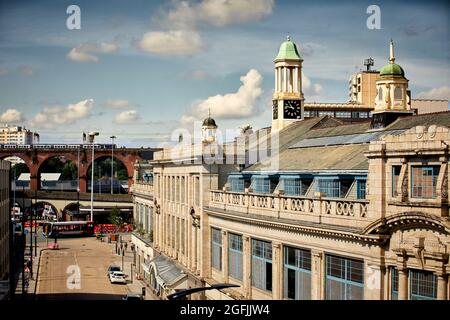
(411, 166), (439, 198)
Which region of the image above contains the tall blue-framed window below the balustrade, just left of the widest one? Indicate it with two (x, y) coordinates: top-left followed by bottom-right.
(284, 247), (311, 300)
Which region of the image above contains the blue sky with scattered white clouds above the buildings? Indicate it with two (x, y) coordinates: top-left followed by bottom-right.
(0, 0), (450, 147)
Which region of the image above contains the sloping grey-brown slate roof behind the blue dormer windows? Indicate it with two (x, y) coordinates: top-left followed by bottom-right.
(244, 111), (450, 172)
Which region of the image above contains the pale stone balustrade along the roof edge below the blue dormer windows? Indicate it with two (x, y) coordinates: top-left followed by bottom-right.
(209, 191), (371, 229)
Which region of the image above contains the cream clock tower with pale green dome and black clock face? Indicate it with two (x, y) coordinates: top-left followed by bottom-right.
(272, 36), (304, 131)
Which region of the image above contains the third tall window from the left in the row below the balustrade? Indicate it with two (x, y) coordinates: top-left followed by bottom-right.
(252, 239), (272, 291)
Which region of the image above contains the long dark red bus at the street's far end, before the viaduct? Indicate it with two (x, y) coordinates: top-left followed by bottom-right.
(42, 221), (94, 238)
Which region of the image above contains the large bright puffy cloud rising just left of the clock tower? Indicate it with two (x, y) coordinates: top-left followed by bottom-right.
(181, 69), (263, 125)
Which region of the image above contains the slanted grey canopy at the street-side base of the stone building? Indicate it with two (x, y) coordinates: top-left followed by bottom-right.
(150, 255), (187, 289)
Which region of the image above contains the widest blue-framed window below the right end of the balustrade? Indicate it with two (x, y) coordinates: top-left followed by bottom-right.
(325, 255), (364, 300)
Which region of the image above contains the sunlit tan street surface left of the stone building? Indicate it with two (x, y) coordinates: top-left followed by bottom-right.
(36, 237), (140, 300)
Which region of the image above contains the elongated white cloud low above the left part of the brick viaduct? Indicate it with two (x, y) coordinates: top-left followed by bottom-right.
(29, 99), (94, 128)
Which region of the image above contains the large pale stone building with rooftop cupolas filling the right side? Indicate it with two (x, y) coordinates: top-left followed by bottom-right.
(132, 39), (450, 300)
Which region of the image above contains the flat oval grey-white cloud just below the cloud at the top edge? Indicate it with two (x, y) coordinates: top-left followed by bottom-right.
(137, 30), (203, 55)
